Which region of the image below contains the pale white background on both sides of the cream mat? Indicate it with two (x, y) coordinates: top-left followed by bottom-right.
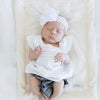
(0, 0), (100, 100)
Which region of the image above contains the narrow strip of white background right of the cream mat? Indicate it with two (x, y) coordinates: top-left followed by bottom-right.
(95, 0), (100, 100)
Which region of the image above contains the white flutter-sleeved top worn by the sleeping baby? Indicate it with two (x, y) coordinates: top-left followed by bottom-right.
(25, 35), (73, 81)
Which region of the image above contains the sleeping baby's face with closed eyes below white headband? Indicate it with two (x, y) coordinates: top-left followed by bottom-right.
(41, 21), (65, 43)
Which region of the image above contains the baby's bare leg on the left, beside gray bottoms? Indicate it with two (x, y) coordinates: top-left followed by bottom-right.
(29, 76), (44, 100)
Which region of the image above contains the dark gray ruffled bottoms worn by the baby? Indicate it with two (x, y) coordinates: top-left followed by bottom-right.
(32, 74), (68, 98)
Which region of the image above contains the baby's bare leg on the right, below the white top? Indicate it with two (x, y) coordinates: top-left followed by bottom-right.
(48, 80), (64, 100)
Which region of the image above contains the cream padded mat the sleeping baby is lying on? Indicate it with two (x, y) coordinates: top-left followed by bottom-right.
(15, 0), (97, 100)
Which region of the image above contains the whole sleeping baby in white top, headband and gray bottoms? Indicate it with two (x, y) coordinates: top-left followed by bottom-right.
(25, 9), (73, 100)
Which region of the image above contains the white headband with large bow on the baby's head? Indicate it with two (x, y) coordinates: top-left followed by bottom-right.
(40, 8), (68, 32)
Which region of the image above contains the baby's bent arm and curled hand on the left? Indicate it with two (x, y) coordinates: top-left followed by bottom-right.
(28, 46), (42, 60)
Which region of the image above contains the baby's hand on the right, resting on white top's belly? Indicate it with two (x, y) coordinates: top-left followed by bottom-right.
(55, 53), (70, 65)
